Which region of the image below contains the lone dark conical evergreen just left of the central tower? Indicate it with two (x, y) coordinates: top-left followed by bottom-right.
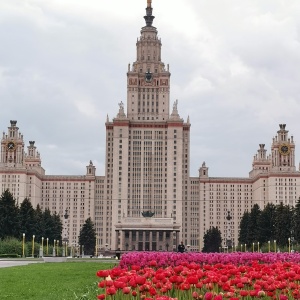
(79, 218), (96, 255)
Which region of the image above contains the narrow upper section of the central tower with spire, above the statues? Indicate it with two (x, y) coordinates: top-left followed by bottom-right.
(127, 1), (171, 121)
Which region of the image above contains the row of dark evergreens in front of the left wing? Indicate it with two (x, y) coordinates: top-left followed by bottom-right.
(0, 190), (63, 241)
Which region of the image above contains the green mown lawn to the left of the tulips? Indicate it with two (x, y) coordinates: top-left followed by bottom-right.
(0, 262), (114, 300)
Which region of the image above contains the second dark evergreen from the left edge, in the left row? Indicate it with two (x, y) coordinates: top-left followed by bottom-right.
(20, 198), (36, 241)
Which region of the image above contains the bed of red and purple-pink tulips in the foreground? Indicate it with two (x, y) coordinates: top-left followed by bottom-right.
(97, 252), (300, 300)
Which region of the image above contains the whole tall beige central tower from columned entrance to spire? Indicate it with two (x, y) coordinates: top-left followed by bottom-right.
(102, 0), (190, 250)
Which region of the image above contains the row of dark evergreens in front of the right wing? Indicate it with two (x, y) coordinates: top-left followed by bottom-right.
(239, 199), (300, 246)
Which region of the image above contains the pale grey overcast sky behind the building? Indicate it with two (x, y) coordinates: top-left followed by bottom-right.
(0, 0), (300, 177)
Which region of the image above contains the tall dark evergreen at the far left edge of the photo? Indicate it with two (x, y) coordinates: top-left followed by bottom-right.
(0, 190), (21, 239)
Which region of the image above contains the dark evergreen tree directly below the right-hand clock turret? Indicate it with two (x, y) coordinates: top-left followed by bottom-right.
(275, 203), (293, 246)
